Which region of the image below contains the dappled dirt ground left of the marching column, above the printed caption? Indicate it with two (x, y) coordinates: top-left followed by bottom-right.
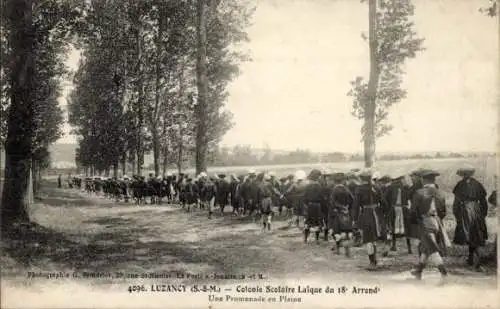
(2, 180), (496, 283)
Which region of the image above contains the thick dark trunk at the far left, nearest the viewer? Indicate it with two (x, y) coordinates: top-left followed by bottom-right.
(0, 0), (35, 230)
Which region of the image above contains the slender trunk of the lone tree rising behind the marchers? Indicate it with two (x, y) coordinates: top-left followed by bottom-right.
(363, 0), (379, 168)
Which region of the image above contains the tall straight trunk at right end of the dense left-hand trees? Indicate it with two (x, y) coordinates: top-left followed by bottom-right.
(195, 0), (208, 174)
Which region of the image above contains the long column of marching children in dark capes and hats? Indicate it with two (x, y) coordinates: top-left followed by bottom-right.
(67, 166), (496, 278)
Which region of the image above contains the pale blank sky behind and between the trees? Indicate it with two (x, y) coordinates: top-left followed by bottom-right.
(60, 0), (498, 152)
